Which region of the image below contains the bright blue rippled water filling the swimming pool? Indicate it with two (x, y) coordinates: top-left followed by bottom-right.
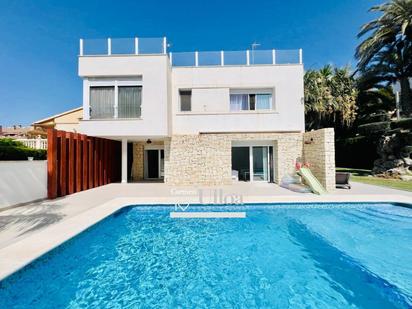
(0, 203), (412, 308)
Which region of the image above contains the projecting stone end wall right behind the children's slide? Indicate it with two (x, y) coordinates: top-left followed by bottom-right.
(303, 128), (336, 191)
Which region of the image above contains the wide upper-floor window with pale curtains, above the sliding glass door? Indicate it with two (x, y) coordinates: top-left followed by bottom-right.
(230, 92), (272, 111)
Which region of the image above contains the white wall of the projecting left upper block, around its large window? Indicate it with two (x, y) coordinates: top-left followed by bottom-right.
(79, 55), (170, 137)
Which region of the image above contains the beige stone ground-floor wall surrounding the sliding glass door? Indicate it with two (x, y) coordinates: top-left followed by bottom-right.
(165, 133), (303, 185)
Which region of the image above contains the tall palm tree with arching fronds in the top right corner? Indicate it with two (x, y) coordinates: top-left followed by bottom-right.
(355, 0), (412, 115)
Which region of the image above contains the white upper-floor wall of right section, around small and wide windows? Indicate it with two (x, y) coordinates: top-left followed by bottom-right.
(172, 65), (305, 134)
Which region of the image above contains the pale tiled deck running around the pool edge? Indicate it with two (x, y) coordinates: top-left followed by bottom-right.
(0, 183), (412, 279)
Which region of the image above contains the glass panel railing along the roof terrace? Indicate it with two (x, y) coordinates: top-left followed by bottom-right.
(80, 37), (303, 67)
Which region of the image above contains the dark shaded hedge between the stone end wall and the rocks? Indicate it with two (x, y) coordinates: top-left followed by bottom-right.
(335, 136), (379, 169)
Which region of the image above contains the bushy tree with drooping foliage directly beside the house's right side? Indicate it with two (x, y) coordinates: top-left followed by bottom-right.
(304, 65), (357, 130)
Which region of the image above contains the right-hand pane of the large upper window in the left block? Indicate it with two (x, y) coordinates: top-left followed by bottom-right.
(117, 86), (142, 118)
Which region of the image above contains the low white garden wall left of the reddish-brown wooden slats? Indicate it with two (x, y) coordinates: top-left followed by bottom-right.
(0, 161), (47, 209)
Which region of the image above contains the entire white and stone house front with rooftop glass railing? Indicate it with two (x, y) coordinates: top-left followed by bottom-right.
(79, 38), (335, 188)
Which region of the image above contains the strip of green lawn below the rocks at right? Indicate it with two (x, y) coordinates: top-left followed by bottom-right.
(336, 167), (412, 192)
